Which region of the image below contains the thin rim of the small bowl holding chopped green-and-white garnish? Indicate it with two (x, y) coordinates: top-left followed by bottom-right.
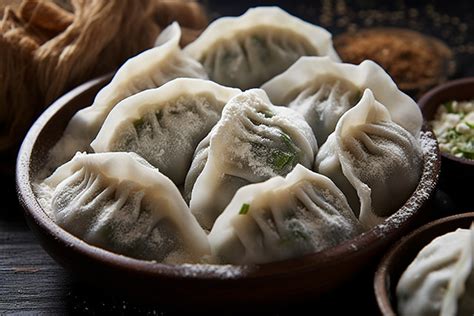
(418, 77), (474, 166)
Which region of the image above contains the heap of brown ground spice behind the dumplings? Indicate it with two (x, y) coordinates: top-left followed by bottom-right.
(334, 28), (455, 97)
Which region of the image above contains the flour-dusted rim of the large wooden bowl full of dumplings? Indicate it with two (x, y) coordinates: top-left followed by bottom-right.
(16, 74), (441, 280)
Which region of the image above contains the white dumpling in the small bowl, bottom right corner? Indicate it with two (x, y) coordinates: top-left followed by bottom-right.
(396, 228), (474, 316)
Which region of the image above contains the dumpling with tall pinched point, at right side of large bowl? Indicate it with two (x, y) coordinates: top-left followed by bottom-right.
(314, 89), (423, 227)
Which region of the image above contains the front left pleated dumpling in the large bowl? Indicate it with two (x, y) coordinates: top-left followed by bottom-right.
(37, 153), (210, 263)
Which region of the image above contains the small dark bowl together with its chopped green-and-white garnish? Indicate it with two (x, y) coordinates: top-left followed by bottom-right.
(418, 77), (474, 207)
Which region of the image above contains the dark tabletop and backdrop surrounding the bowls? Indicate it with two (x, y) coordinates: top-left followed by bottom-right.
(0, 0), (474, 315)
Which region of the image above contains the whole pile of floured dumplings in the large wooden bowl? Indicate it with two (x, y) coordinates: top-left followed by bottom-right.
(34, 7), (434, 265)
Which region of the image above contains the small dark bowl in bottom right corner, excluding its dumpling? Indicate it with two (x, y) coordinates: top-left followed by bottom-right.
(374, 212), (474, 316)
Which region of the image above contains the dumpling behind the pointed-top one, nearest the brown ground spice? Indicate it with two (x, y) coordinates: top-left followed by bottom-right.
(262, 57), (423, 146)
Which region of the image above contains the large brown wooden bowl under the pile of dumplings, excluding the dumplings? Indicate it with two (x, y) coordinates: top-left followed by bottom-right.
(16, 76), (440, 306)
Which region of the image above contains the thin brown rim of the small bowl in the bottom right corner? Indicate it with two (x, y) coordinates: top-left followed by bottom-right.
(373, 211), (474, 316)
